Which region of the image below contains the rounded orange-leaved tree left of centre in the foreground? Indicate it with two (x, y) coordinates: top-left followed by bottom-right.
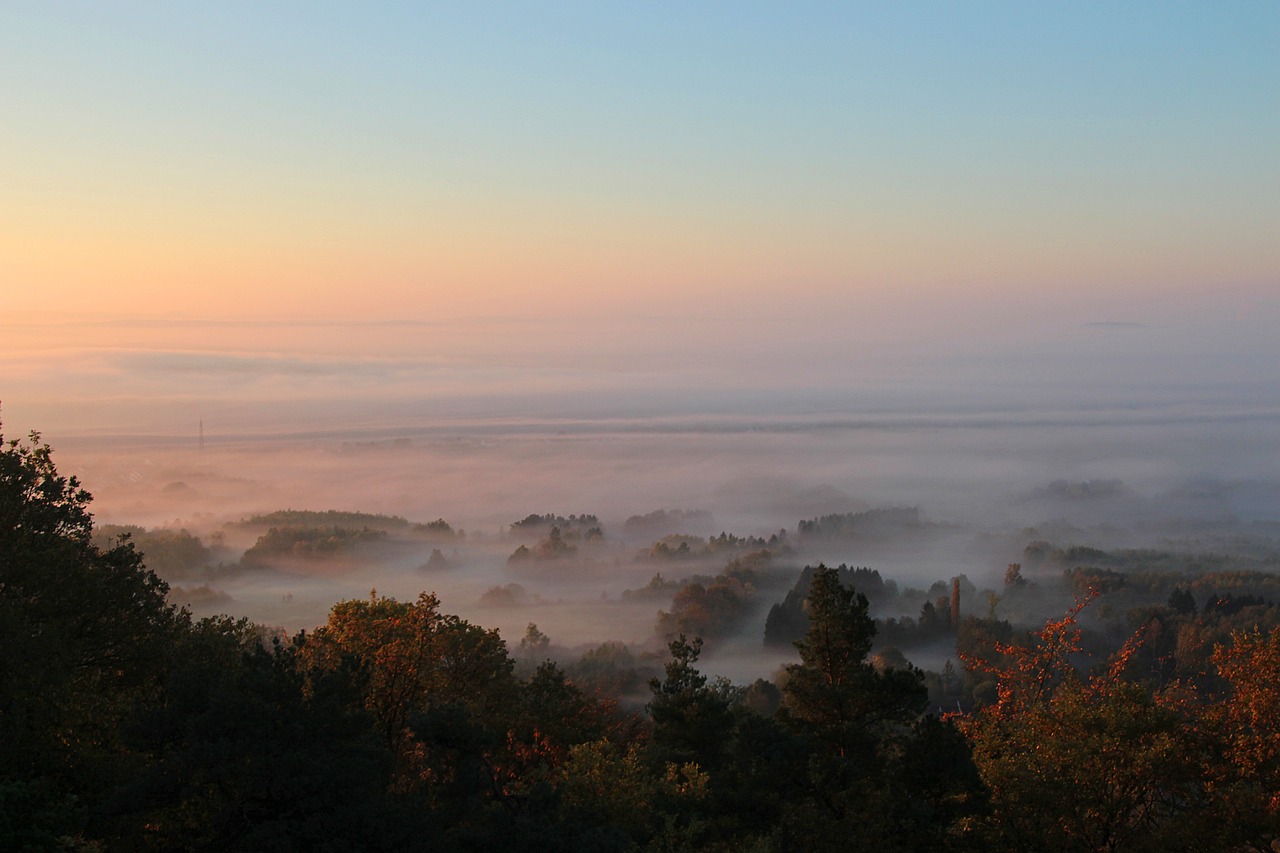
(300, 584), (637, 849)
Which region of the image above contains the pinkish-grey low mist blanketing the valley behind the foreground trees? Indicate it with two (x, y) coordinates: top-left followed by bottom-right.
(49, 389), (1280, 683)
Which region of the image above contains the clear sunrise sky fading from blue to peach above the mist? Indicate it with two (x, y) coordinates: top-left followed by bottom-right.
(0, 1), (1280, 434)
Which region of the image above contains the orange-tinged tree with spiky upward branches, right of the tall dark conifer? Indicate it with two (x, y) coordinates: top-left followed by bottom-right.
(959, 594), (1213, 852)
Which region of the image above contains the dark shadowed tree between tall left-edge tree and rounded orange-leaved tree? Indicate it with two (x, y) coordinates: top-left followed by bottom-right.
(110, 617), (419, 850)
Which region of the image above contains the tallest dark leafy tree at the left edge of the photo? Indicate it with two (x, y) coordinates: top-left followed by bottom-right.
(0, 433), (187, 848)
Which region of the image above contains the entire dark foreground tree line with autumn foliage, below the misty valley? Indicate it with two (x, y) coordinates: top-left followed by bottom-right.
(0, 427), (1280, 850)
